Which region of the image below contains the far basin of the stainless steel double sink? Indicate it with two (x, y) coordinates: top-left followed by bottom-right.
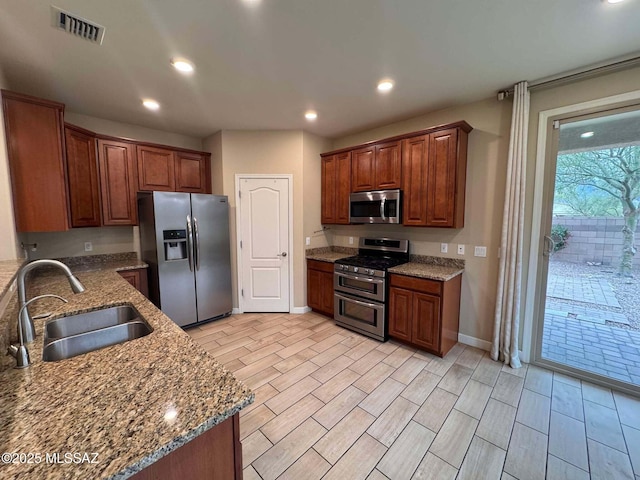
(45, 305), (140, 338)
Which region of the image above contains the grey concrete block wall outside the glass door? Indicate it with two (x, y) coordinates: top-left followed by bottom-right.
(553, 216), (640, 268)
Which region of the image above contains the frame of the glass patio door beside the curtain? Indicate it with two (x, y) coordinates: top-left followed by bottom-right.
(522, 91), (640, 396)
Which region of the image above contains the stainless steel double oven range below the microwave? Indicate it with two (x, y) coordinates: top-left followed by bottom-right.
(333, 238), (409, 342)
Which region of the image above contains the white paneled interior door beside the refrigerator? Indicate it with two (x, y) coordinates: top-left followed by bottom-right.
(238, 177), (291, 312)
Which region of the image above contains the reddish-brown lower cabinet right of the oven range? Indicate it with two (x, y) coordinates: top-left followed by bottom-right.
(389, 274), (462, 357)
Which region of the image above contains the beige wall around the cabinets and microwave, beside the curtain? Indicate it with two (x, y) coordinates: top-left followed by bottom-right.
(331, 99), (511, 346)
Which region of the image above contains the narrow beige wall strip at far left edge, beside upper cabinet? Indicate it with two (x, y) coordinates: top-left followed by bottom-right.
(0, 69), (23, 260)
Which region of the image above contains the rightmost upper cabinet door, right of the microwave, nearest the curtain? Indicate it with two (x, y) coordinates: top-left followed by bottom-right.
(426, 128), (458, 227)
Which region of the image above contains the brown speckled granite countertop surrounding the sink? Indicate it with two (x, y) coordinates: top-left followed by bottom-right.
(0, 261), (254, 479)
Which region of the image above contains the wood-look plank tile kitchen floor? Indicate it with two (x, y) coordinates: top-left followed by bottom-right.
(188, 313), (640, 480)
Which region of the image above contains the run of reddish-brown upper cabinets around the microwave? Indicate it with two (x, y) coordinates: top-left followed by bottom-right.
(321, 121), (473, 228)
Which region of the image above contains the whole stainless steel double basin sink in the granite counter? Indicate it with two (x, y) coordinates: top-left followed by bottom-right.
(42, 305), (153, 362)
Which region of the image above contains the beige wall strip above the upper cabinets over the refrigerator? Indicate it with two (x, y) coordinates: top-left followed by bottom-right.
(64, 111), (202, 150)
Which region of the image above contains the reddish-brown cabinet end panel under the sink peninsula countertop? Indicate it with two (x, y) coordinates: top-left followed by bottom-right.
(131, 413), (242, 480)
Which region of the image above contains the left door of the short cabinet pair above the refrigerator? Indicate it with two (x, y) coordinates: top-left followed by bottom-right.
(136, 145), (176, 192)
